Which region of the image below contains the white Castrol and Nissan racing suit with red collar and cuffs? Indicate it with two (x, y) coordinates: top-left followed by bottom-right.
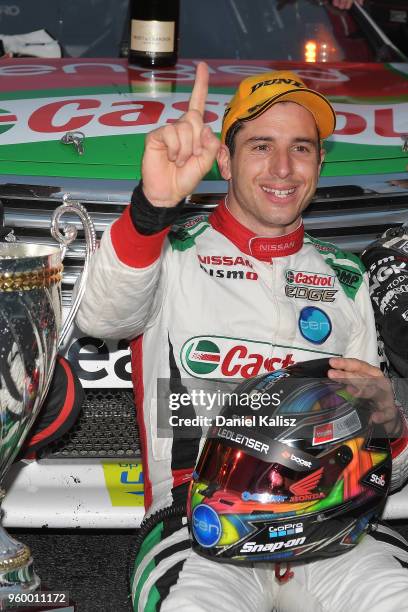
(77, 198), (408, 612)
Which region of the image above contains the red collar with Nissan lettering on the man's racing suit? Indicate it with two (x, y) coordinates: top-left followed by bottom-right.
(209, 201), (305, 262)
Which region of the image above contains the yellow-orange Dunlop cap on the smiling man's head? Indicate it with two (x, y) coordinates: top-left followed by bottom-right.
(221, 70), (336, 142)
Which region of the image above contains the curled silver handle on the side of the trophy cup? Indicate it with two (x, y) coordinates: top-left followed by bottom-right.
(51, 194), (96, 350)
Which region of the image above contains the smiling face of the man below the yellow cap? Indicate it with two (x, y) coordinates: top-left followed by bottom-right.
(218, 102), (324, 236)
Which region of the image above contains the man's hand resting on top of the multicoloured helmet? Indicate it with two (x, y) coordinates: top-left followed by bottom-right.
(327, 357), (401, 438)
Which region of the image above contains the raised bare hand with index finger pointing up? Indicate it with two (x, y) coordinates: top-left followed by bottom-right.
(142, 62), (220, 208)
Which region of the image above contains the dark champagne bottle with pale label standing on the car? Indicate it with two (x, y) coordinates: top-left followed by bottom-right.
(129, 0), (179, 68)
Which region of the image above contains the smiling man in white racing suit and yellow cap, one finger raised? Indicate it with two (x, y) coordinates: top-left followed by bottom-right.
(78, 64), (408, 612)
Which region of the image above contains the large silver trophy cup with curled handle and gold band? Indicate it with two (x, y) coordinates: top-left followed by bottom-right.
(0, 196), (96, 596)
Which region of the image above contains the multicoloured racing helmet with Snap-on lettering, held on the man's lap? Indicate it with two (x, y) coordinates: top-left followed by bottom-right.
(187, 359), (391, 563)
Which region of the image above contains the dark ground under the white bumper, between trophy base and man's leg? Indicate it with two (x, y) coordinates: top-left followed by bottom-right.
(8, 529), (137, 612)
